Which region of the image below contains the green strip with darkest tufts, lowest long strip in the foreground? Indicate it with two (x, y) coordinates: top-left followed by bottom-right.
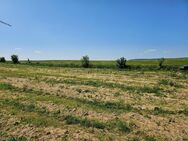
(0, 99), (133, 132)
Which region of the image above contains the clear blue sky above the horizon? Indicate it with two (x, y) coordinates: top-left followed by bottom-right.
(0, 0), (188, 60)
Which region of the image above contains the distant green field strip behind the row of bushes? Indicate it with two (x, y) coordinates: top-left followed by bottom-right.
(5, 58), (188, 69)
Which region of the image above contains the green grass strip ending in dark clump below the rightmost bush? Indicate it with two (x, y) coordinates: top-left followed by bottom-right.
(0, 73), (163, 96)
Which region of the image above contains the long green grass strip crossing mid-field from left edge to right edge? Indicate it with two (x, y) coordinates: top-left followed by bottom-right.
(0, 83), (186, 115)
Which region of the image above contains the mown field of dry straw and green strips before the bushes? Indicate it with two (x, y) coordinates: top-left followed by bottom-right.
(0, 63), (188, 141)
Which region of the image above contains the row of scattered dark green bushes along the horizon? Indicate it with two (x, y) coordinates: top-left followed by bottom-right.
(0, 55), (165, 69)
